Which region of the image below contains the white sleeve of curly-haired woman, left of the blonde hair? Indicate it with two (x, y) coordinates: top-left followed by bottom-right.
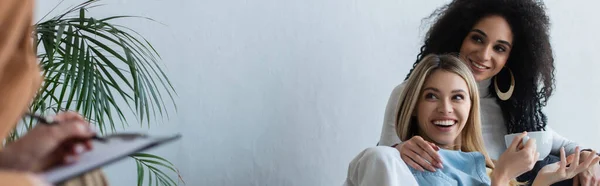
(378, 83), (405, 146)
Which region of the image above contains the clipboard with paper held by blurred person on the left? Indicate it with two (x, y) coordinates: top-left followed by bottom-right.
(40, 133), (181, 184)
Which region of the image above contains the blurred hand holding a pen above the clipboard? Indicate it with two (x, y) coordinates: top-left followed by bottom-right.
(0, 112), (101, 172)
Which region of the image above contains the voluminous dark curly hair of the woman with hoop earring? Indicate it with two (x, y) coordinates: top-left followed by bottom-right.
(406, 0), (554, 133)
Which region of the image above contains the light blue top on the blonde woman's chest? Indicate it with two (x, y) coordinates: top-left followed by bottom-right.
(408, 149), (491, 186)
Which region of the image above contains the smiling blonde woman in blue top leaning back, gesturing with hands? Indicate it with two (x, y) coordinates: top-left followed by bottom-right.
(345, 54), (600, 186)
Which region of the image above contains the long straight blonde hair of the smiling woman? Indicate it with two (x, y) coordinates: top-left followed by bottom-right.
(396, 54), (522, 185)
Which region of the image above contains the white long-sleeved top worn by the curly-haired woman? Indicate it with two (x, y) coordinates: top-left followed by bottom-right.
(379, 79), (584, 159)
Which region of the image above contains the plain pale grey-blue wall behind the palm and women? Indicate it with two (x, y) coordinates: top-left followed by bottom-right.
(36, 0), (600, 186)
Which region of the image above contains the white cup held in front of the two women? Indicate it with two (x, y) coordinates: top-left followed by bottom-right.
(504, 131), (552, 160)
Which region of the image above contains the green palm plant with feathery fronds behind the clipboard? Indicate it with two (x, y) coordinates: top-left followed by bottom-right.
(11, 0), (183, 185)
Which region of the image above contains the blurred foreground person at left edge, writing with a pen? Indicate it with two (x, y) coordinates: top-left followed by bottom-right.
(0, 0), (108, 186)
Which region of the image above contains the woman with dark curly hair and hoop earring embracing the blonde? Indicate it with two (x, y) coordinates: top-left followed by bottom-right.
(344, 0), (600, 185)
